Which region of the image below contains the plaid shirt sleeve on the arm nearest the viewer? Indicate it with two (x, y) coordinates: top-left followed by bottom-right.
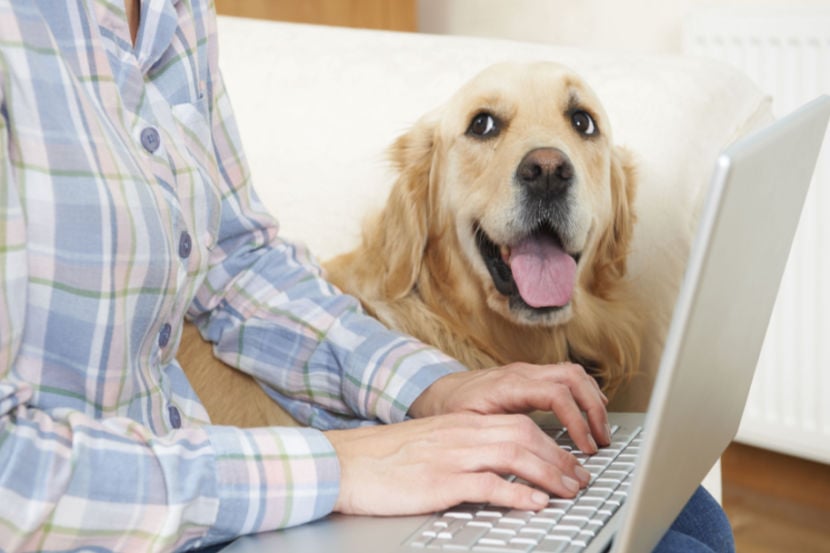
(0, 103), (339, 551)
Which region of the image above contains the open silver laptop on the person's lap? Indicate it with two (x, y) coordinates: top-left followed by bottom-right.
(223, 96), (830, 553)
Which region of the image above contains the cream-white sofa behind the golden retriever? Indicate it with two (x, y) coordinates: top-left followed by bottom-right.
(181, 12), (770, 493)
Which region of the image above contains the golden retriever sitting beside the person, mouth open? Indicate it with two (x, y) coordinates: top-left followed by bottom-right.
(186, 62), (641, 425)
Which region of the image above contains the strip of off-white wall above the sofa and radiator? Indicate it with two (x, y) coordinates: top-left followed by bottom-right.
(418, 0), (830, 53)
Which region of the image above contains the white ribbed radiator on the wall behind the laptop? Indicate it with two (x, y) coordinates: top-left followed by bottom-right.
(683, 10), (830, 463)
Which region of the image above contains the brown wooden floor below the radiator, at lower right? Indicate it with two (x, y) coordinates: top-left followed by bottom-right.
(723, 444), (830, 553)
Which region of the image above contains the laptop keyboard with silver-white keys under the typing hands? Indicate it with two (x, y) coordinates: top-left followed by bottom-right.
(405, 427), (642, 553)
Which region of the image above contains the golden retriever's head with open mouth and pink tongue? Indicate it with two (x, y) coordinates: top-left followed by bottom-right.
(386, 63), (634, 325)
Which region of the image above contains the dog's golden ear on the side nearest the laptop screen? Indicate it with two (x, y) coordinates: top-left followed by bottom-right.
(591, 146), (637, 297)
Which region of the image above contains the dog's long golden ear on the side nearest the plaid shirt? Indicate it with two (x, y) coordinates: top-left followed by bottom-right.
(373, 114), (437, 299)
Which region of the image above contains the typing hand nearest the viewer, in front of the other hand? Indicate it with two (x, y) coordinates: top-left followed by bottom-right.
(326, 413), (590, 515)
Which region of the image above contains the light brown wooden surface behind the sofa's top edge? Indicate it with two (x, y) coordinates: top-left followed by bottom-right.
(216, 0), (418, 31)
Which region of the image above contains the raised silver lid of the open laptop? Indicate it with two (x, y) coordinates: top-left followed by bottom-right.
(614, 96), (830, 551)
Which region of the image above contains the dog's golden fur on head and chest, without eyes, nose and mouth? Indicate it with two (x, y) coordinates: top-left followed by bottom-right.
(325, 63), (639, 393)
